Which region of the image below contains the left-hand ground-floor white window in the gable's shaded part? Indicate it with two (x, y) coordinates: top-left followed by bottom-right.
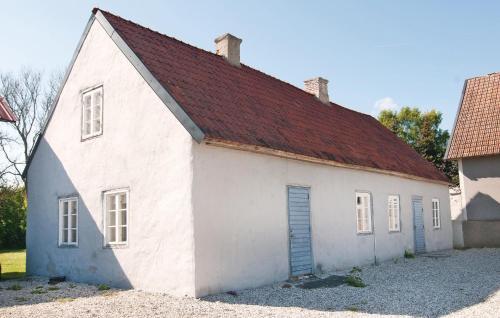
(59, 198), (78, 246)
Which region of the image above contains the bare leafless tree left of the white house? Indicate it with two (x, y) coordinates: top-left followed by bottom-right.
(0, 69), (62, 186)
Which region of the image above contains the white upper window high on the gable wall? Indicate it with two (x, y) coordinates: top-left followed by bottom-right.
(82, 86), (102, 139)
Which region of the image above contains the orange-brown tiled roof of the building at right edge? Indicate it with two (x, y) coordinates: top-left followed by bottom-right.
(447, 73), (500, 159)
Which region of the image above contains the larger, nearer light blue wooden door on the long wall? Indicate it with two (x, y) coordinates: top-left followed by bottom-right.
(288, 186), (312, 276)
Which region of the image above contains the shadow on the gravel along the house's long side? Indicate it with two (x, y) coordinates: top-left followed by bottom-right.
(202, 249), (500, 317)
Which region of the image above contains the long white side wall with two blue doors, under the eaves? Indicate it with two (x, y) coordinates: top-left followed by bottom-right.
(193, 144), (452, 296)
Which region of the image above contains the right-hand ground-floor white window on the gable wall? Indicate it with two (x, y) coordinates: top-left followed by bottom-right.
(104, 190), (128, 246)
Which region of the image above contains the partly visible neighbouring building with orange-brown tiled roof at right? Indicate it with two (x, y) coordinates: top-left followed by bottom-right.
(446, 73), (500, 247)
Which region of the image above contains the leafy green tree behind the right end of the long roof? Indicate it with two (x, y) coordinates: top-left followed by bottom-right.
(378, 107), (458, 185)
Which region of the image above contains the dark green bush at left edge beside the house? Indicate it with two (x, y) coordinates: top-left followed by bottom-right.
(0, 186), (26, 249)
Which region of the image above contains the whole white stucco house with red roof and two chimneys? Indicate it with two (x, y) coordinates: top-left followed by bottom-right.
(25, 9), (452, 297)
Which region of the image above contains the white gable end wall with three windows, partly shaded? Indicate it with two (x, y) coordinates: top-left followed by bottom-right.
(27, 22), (194, 295)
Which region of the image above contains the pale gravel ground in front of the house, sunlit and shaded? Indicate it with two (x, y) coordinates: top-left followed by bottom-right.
(0, 249), (500, 318)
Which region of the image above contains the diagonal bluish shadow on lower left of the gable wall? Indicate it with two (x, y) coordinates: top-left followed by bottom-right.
(26, 139), (132, 306)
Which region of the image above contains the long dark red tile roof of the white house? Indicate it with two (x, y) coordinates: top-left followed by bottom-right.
(101, 11), (448, 181)
